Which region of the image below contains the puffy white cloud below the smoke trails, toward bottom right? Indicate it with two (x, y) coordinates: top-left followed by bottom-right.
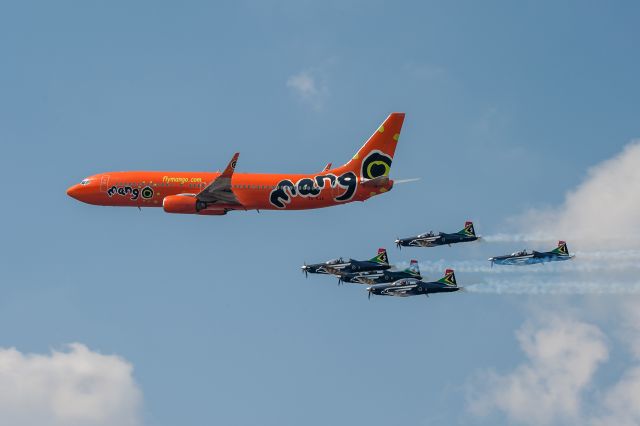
(469, 316), (608, 425)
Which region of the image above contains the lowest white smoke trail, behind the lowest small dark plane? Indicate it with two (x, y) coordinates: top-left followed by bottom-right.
(464, 279), (640, 295)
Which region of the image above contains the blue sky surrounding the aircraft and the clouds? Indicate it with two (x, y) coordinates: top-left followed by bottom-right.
(0, 1), (640, 425)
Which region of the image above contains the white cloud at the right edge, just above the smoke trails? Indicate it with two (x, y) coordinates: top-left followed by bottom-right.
(522, 141), (640, 248)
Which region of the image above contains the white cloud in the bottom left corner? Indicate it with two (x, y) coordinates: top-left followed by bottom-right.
(0, 343), (142, 426)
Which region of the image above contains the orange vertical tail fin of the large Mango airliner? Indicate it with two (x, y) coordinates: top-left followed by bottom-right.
(335, 112), (404, 179)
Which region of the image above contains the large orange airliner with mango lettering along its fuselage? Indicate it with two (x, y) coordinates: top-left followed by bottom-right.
(67, 112), (404, 215)
